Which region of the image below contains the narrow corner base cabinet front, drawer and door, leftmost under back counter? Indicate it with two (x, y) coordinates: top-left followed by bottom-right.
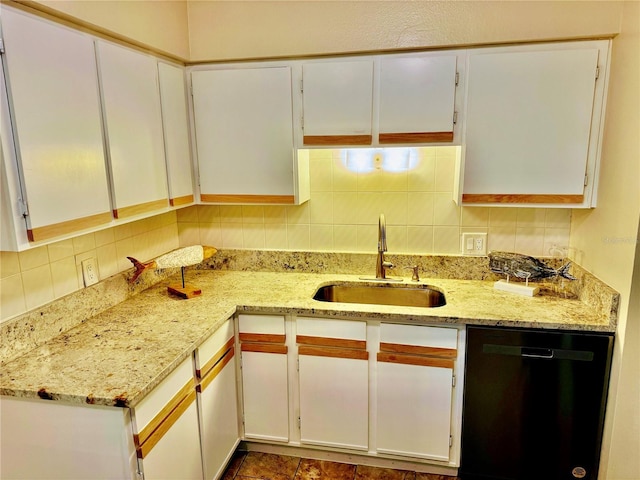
(239, 315), (289, 442)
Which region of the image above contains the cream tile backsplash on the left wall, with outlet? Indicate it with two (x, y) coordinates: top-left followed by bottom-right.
(0, 211), (179, 321)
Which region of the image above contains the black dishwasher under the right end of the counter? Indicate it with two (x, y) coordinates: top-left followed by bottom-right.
(459, 327), (613, 480)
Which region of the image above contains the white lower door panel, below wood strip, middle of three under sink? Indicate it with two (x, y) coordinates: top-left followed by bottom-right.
(298, 354), (369, 450)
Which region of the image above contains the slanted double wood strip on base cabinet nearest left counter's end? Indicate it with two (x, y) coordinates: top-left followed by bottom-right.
(133, 380), (196, 458)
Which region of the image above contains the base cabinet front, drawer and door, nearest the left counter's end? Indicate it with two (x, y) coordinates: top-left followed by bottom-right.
(134, 356), (202, 480)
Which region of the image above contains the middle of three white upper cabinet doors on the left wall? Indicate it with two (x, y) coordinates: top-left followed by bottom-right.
(97, 41), (169, 218)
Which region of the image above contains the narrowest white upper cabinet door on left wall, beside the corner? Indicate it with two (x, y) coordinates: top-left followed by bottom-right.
(158, 62), (193, 207)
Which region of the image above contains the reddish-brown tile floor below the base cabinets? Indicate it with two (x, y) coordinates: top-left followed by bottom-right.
(222, 452), (459, 480)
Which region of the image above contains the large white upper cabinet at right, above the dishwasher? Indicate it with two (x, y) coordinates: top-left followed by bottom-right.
(462, 41), (610, 207)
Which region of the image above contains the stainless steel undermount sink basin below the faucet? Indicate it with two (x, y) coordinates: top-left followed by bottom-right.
(313, 284), (447, 308)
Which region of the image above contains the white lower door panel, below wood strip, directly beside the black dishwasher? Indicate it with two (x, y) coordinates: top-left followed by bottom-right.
(377, 362), (453, 461)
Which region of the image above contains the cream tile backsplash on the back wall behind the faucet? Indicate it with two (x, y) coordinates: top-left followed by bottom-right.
(177, 147), (571, 256)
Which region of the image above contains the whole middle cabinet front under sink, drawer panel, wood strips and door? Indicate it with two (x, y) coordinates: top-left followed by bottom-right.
(296, 318), (369, 450)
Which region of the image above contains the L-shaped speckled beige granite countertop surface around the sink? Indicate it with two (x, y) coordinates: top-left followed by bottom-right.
(0, 270), (615, 407)
